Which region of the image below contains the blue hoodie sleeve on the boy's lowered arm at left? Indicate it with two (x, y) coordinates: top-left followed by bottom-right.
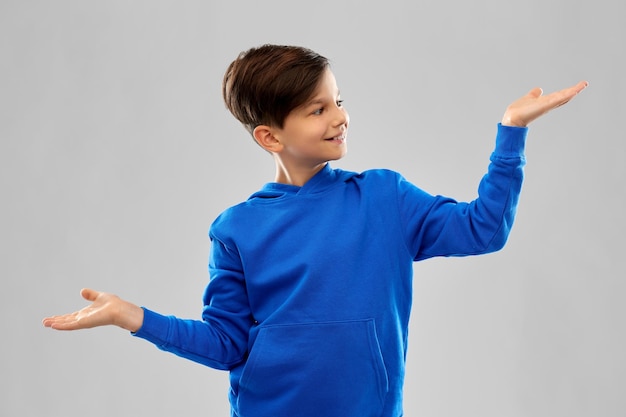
(133, 231), (252, 370)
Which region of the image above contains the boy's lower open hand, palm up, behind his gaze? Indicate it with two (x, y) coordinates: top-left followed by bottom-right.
(43, 288), (143, 332)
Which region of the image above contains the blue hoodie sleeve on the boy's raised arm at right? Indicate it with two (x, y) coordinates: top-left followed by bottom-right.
(397, 124), (528, 261)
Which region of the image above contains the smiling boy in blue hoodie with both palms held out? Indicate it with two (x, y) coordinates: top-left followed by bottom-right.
(44, 45), (587, 417)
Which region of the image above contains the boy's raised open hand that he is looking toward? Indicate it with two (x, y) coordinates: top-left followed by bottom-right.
(502, 81), (589, 127)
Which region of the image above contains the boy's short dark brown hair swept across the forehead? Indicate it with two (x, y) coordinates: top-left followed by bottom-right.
(222, 45), (329, 133)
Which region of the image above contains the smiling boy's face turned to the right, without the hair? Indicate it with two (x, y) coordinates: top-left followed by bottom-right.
(272, 69), (350, 169)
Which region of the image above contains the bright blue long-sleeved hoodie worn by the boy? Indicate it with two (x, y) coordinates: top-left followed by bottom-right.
(135, 125), (527, 417)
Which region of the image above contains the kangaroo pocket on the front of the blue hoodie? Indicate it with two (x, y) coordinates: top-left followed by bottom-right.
(233, 319), (388, 417)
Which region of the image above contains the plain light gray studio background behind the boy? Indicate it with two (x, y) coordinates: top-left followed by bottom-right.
(0, 0), (626, 417)
